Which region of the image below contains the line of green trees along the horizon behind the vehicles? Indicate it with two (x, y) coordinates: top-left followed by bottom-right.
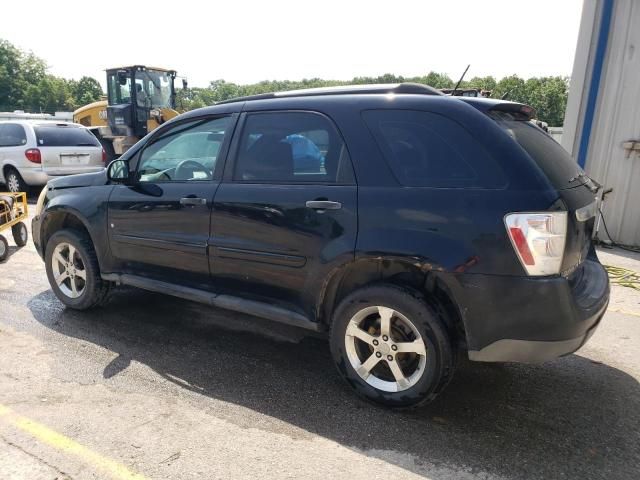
(0, 39), (569, 126)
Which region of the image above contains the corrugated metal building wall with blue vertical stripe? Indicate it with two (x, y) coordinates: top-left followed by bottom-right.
(562, 0), (640, 245)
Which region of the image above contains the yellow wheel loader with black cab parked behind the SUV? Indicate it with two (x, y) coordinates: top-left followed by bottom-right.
(73, 65), (187, 161)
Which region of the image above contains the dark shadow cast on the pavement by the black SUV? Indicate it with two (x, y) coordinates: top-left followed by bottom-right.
(28, 289), (640, 479)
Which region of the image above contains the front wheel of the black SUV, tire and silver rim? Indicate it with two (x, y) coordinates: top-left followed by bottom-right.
(45, 230), (110, 310)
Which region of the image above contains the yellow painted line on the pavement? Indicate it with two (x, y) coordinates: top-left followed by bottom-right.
(0, 404), (146, 480)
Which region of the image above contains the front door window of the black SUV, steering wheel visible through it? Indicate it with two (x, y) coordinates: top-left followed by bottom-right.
(138, 117), (231, 182)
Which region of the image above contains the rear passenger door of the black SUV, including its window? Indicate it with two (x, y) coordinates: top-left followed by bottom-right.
(210, 111), (357, 318)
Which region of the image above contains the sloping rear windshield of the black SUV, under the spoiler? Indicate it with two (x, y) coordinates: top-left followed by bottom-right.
(490, 112), (584, 190)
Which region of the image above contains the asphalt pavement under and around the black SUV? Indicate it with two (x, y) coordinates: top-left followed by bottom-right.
(0, 203), (640, 480)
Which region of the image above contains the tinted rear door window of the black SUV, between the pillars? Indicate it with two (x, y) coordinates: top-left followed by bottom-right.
(233, 112), (353, 183)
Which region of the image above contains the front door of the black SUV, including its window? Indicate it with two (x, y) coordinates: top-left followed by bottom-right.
(108, 116), (235, 288)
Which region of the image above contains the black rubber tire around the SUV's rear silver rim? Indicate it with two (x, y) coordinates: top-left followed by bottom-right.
(331, 284), (456, 408)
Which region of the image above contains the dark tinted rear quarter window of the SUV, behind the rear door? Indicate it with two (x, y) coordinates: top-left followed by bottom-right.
(362, 110), (506, 188)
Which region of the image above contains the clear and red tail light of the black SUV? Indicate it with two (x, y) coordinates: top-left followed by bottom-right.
(504, 212), (567, 275)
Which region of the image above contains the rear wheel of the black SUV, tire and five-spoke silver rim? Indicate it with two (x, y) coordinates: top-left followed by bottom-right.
(331, 285), (455, 407)
